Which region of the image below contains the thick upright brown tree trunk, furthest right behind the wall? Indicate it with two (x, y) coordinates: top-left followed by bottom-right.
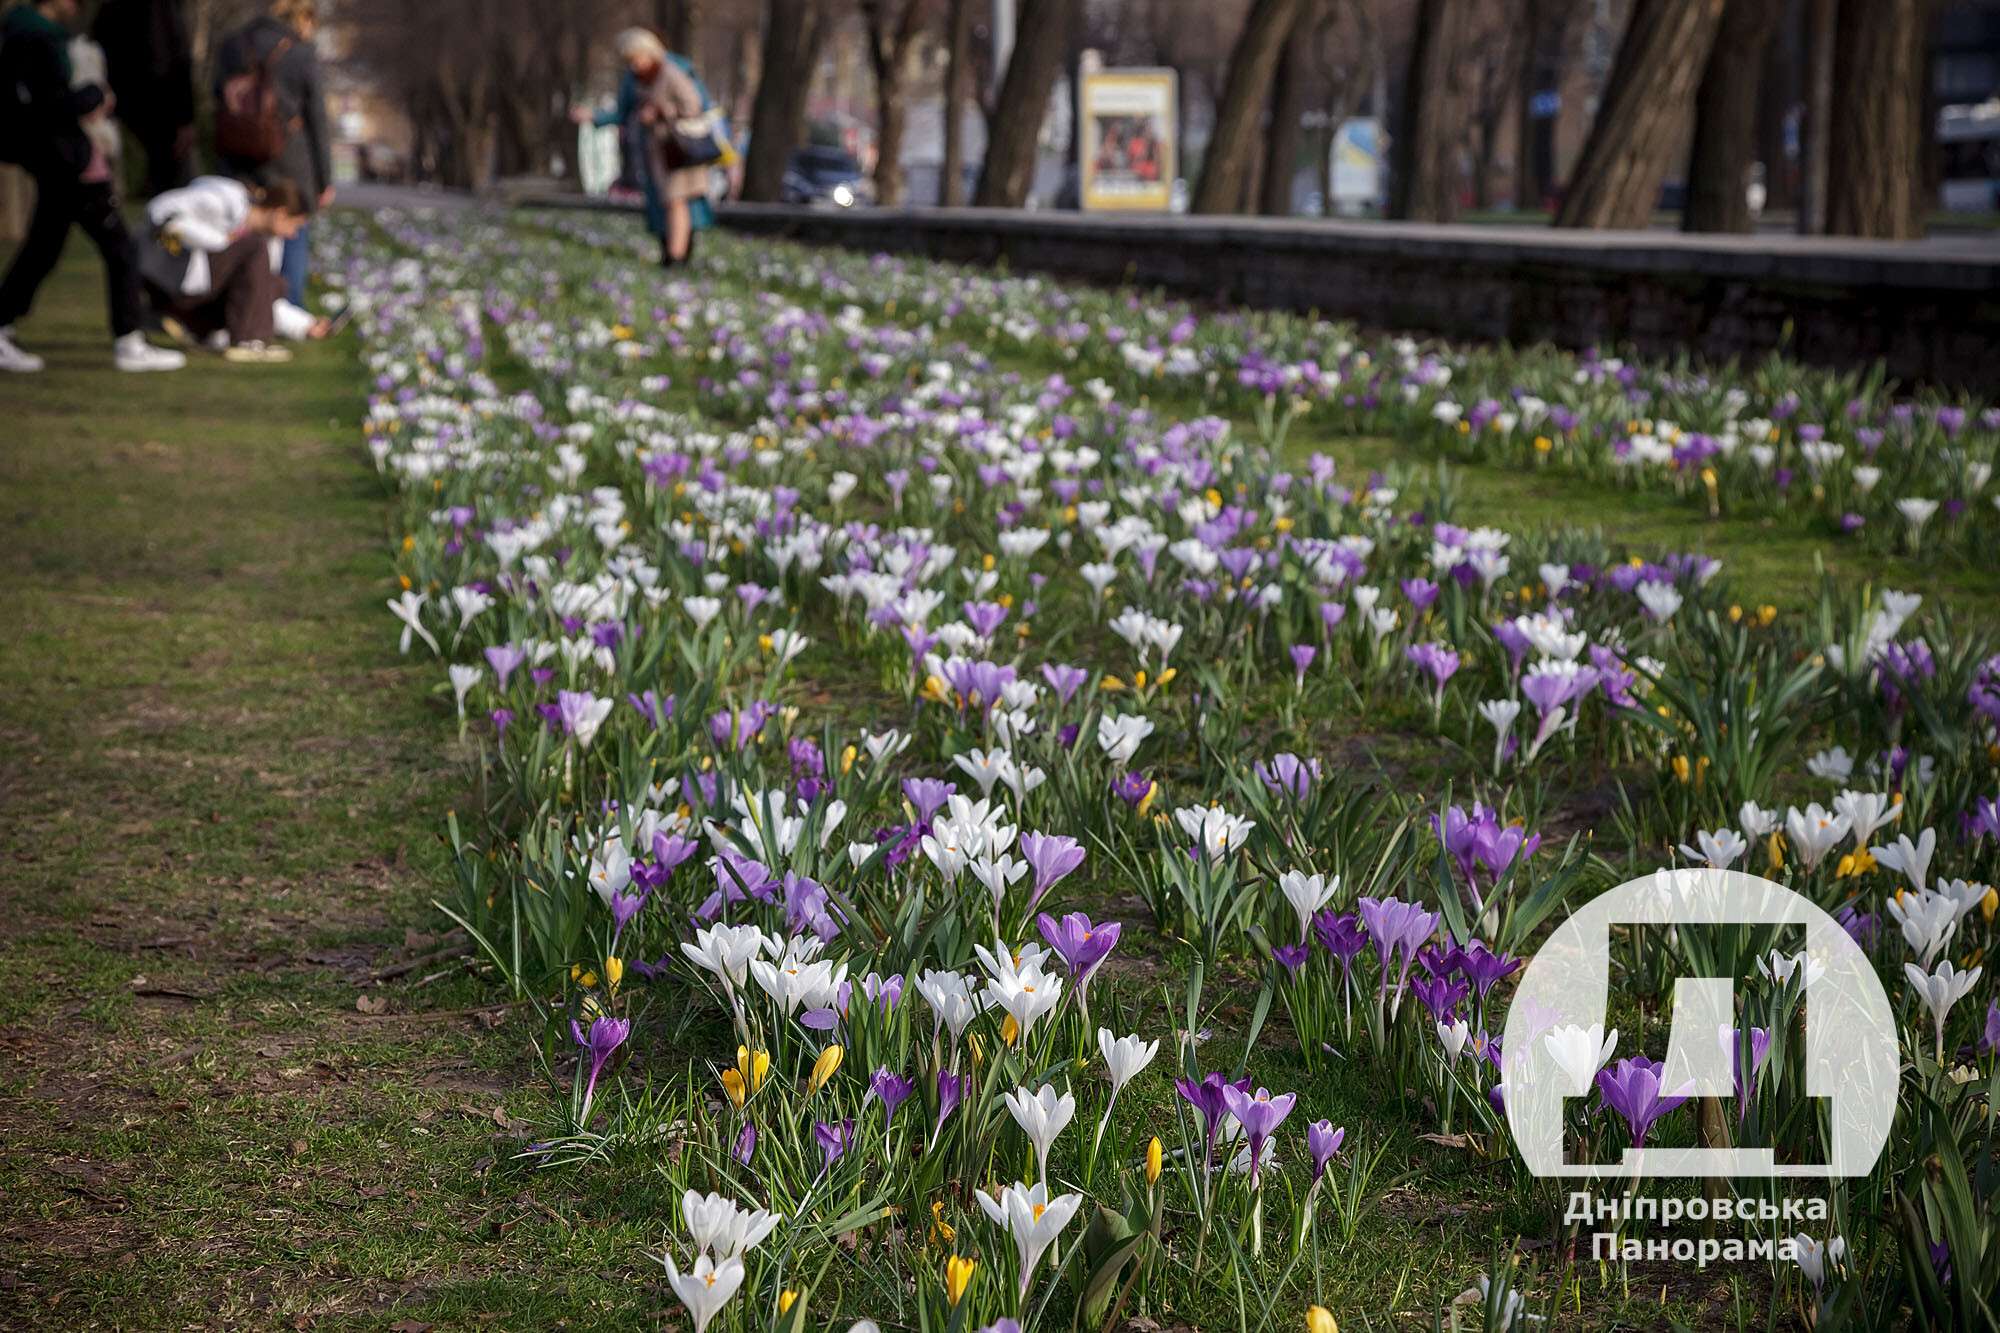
(1826, 0), (1930, 240)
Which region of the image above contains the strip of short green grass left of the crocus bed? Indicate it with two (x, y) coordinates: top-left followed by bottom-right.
(0, 244), (662, 1327)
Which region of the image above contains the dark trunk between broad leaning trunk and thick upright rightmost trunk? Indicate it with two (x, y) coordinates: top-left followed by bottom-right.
(1680, 0), (1784, 232)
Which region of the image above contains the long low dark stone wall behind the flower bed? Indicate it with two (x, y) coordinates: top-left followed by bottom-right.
(720, 204), (2000, 394)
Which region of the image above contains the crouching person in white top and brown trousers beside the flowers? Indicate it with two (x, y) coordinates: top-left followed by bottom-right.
(138, 176), (328, 362)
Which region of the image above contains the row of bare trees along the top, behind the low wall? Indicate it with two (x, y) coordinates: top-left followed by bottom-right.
(340, 0), (1942, 236)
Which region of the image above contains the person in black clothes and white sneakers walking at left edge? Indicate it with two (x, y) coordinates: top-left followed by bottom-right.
(0, 0), (188, 374)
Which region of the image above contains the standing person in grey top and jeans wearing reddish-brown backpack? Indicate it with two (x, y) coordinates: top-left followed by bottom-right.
(216, 0), (334, 306)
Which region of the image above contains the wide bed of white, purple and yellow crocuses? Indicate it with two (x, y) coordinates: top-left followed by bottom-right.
(330, 214), (2000, 1329)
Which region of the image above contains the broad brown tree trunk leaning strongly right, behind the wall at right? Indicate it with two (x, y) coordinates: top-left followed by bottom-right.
(1556, 0), (1724, 230)
